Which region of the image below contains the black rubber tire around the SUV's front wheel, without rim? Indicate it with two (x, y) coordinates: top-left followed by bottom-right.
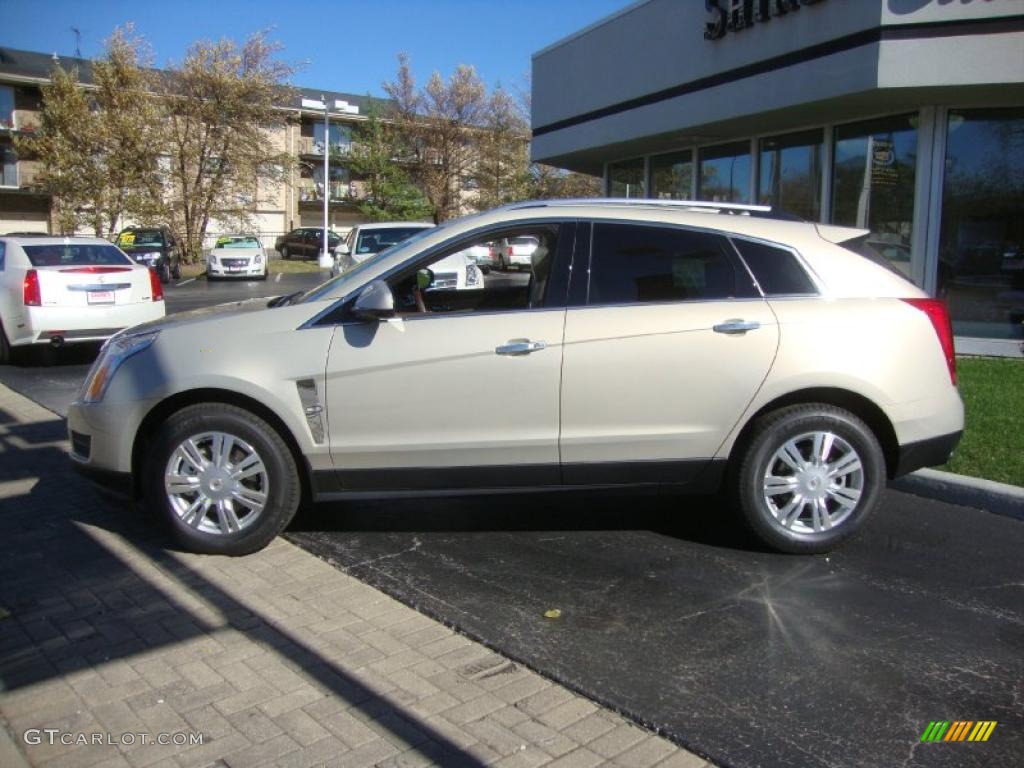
(142, 402), (301, 555)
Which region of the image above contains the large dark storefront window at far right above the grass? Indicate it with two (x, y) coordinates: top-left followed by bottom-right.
(938, 108), (1024, 339)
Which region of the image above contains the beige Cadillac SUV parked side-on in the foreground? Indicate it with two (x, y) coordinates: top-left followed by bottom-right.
(68, 200), (964, 555)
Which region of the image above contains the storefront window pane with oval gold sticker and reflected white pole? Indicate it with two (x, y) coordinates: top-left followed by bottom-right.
(831, 115), (918, 278)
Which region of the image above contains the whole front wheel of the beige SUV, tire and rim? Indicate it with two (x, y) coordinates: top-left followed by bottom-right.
(143, 403), (301, 555)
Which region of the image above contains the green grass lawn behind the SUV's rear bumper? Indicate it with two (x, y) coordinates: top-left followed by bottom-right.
(939, 357), (1024, 485)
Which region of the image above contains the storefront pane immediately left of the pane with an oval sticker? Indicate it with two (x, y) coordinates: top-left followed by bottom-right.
(758, 130), (823, 221)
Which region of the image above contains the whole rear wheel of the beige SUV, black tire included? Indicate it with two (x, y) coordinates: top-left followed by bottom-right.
(730, 402), (887, 554)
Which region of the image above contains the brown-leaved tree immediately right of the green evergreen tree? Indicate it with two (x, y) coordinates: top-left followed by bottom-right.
(384, 54), (486, 222)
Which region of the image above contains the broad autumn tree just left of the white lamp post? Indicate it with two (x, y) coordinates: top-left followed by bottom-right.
(161, 32), (293, 260)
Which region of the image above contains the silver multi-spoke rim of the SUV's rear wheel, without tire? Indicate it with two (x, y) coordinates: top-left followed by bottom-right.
(762, 432), (864, 534)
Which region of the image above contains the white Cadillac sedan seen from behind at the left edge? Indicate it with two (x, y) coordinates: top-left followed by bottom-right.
(0, 236), (164, 362)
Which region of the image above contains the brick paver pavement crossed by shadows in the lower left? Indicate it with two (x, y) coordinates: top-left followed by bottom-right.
(0, 385), (706, 768)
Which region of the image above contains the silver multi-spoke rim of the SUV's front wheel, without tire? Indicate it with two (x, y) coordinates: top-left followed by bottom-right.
(164, 432), (269, 535)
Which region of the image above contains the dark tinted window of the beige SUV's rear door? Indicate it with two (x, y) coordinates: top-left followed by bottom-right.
(588, 223), (757, 304)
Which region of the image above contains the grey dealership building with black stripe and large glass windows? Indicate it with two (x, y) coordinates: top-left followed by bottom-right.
(531, 0), (1024, 356)
